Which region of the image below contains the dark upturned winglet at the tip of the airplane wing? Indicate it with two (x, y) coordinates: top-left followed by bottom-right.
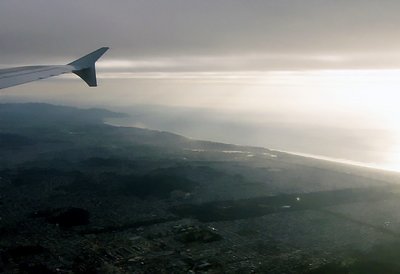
(68, 47), (109, 87)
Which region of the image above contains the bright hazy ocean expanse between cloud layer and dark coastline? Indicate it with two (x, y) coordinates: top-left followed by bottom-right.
(1, 67), (400, 170)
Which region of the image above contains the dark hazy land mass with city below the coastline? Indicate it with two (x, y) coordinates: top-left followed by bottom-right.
(0, 104), (400, 273)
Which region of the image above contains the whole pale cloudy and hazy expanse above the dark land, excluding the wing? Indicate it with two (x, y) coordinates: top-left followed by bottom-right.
(0, 0), (400, 170)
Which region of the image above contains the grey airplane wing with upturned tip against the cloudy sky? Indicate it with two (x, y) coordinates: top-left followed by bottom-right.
(0, 47), (108, 89)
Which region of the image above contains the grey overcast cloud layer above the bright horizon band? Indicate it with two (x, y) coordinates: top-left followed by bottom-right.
(0, 0), (400, 70)
